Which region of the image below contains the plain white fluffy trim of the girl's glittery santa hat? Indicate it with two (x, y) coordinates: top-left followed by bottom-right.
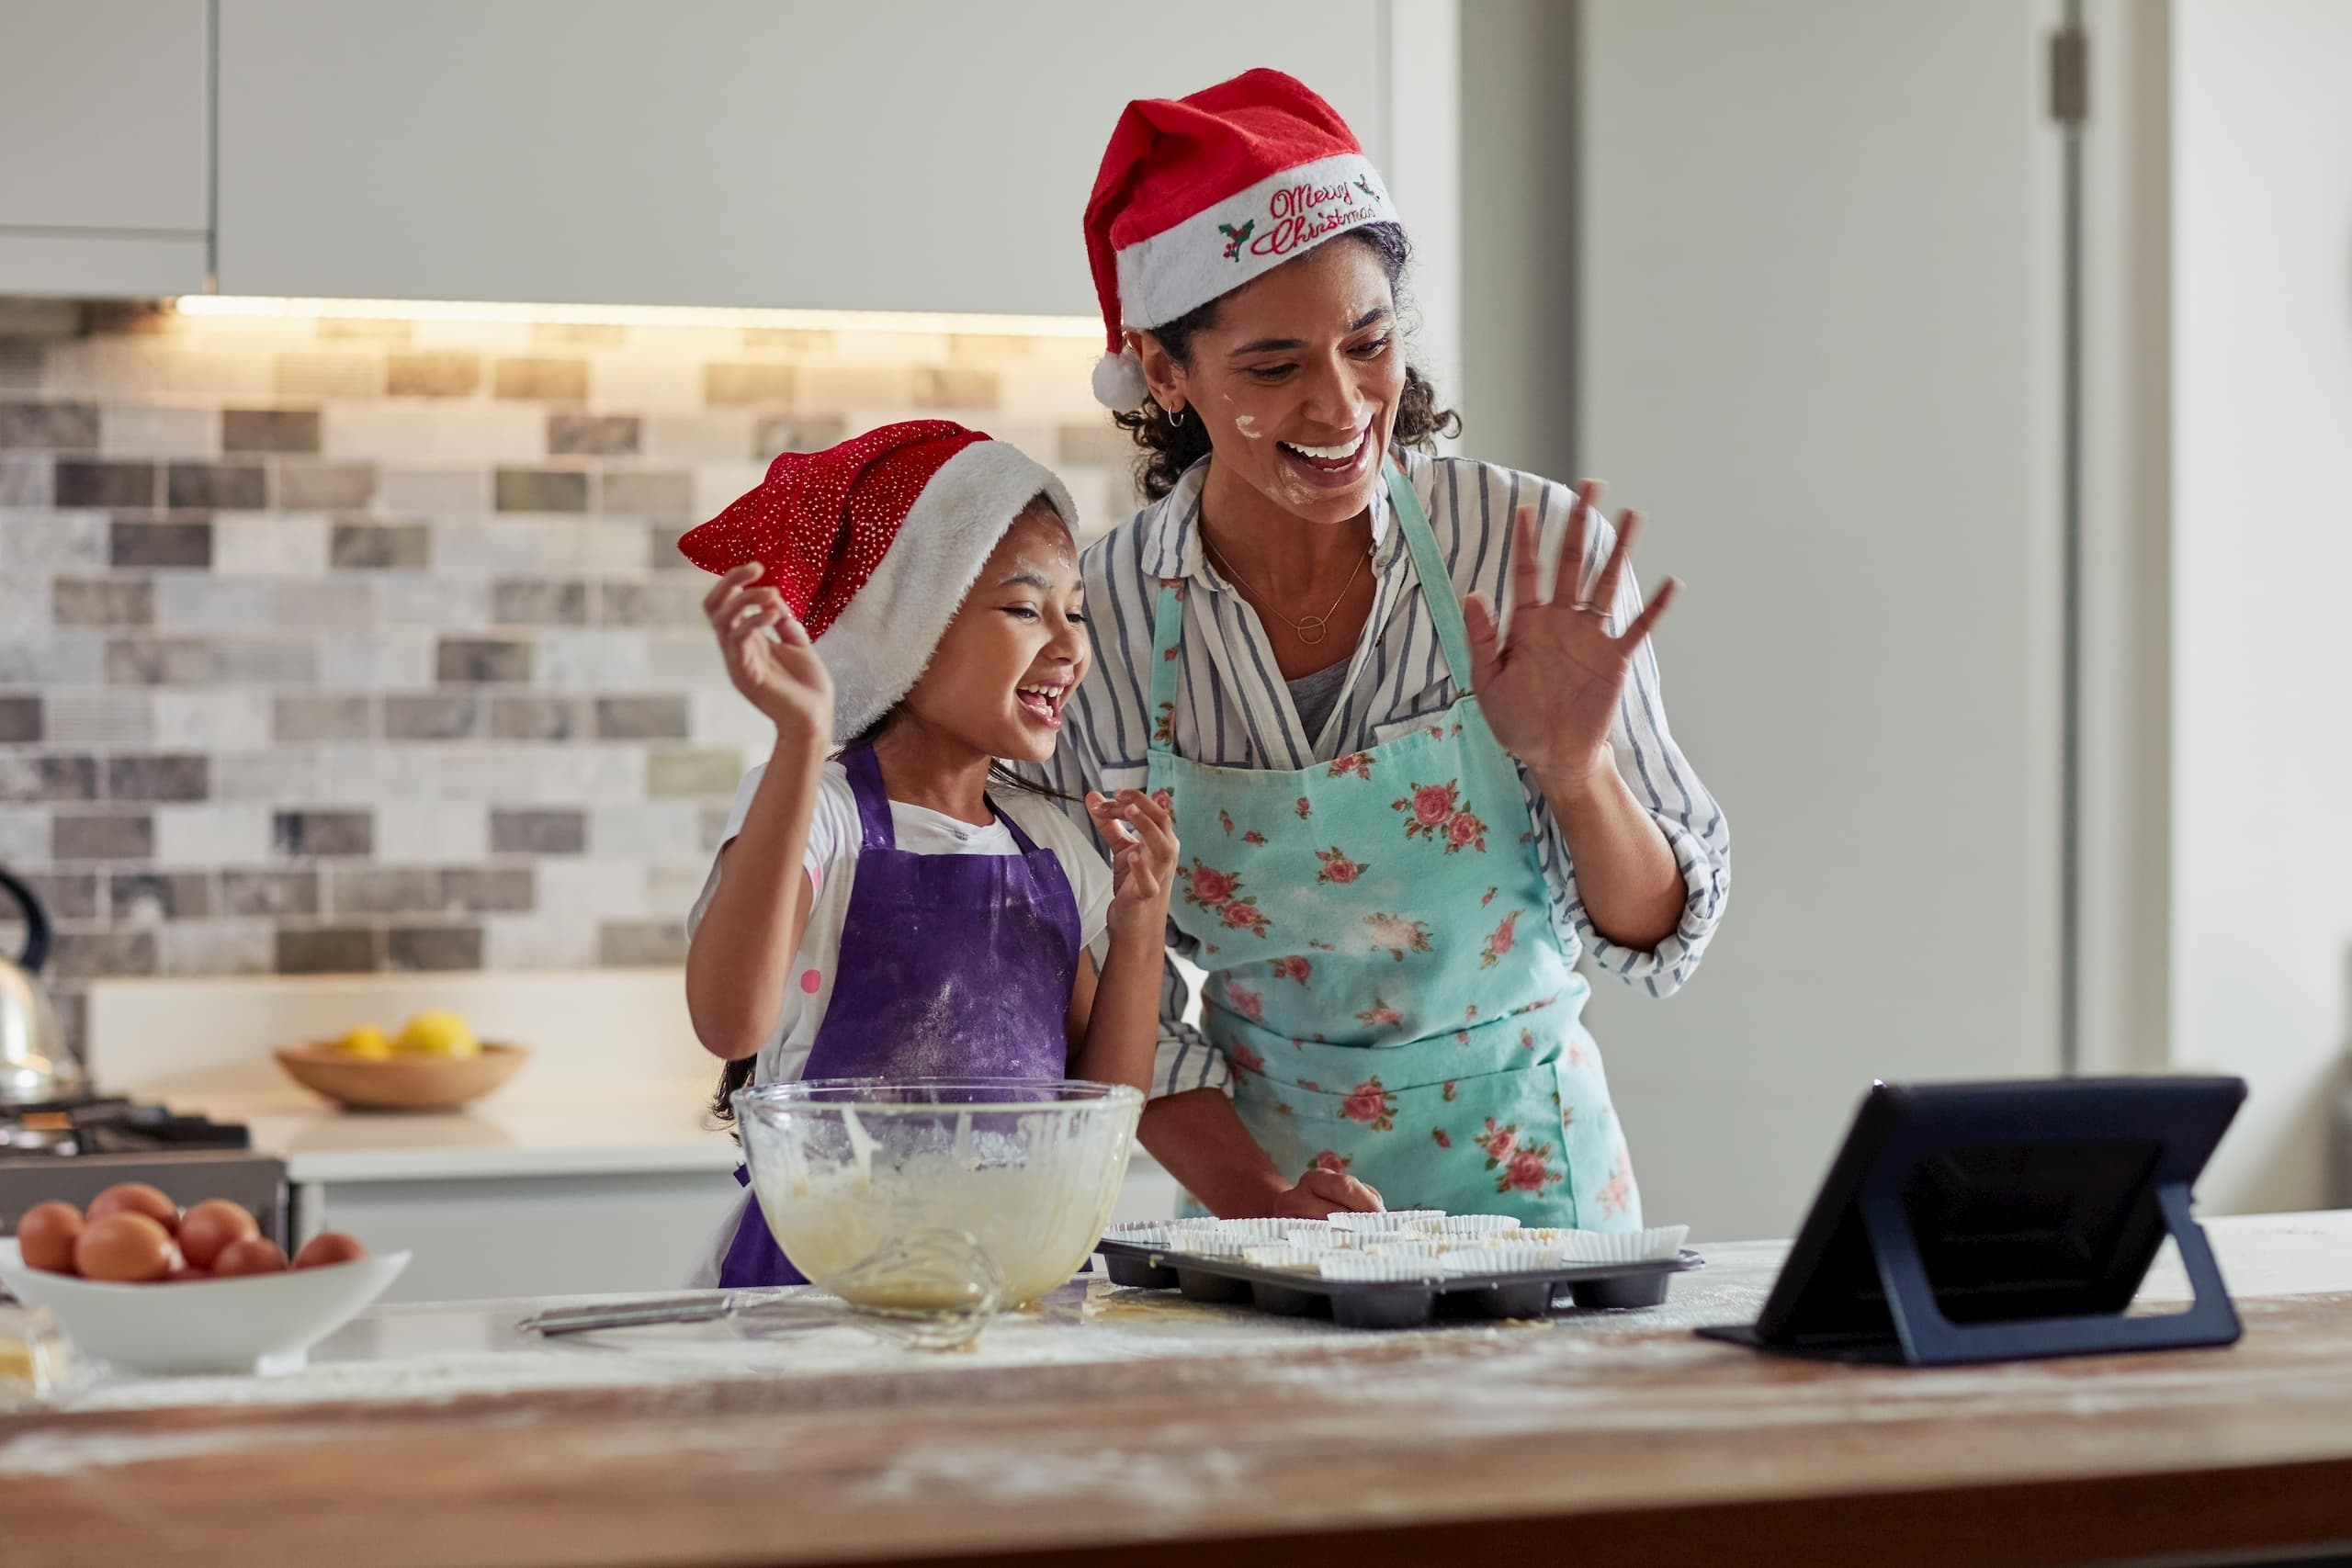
(816, 440), (1077, 743)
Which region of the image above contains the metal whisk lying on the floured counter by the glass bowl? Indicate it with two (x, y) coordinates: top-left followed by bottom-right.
(515, 1229), (1004, 1349)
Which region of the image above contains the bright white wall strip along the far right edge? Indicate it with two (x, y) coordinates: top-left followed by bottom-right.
(2171, 0), (2352, 1208)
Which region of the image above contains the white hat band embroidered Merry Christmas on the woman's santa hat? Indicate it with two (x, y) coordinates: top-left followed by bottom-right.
(1117, 152), (1397, 333)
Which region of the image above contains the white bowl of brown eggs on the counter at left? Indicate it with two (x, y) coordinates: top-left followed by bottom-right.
(0, 1182), (409, 1373)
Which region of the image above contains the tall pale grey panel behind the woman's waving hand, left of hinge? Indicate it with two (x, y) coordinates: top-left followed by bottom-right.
(1571, 0), (2061, 1236)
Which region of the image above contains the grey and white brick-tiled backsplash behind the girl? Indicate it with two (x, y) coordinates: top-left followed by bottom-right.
(0, 301), (1131, 1062)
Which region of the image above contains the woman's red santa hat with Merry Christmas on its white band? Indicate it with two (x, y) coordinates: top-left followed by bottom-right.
(1087, 71), (1397, 409)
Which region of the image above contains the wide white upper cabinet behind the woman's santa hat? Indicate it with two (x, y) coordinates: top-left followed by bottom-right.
(219, 0), (1407, 312)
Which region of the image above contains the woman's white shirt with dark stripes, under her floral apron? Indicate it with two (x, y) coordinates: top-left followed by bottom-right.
(1023, 451), (1731, 1096)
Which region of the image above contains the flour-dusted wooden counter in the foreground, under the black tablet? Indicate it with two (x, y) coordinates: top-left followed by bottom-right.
(0, 1215), (2352, 1568)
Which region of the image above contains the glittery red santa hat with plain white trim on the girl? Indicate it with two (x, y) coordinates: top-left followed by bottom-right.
(677, 419), (1077, 740)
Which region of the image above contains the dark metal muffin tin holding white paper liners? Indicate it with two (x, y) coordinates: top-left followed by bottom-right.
(1096, 1236), (1705, 1328)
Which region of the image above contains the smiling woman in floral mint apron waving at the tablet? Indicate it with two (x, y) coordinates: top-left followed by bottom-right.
(1042, 71), (1729, 1229)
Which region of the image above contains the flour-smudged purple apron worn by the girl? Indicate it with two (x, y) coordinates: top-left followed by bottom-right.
(719, 748), (1082, 1291)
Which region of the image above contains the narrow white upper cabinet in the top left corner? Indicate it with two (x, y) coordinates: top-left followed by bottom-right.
(0, 0), (211, 296)
